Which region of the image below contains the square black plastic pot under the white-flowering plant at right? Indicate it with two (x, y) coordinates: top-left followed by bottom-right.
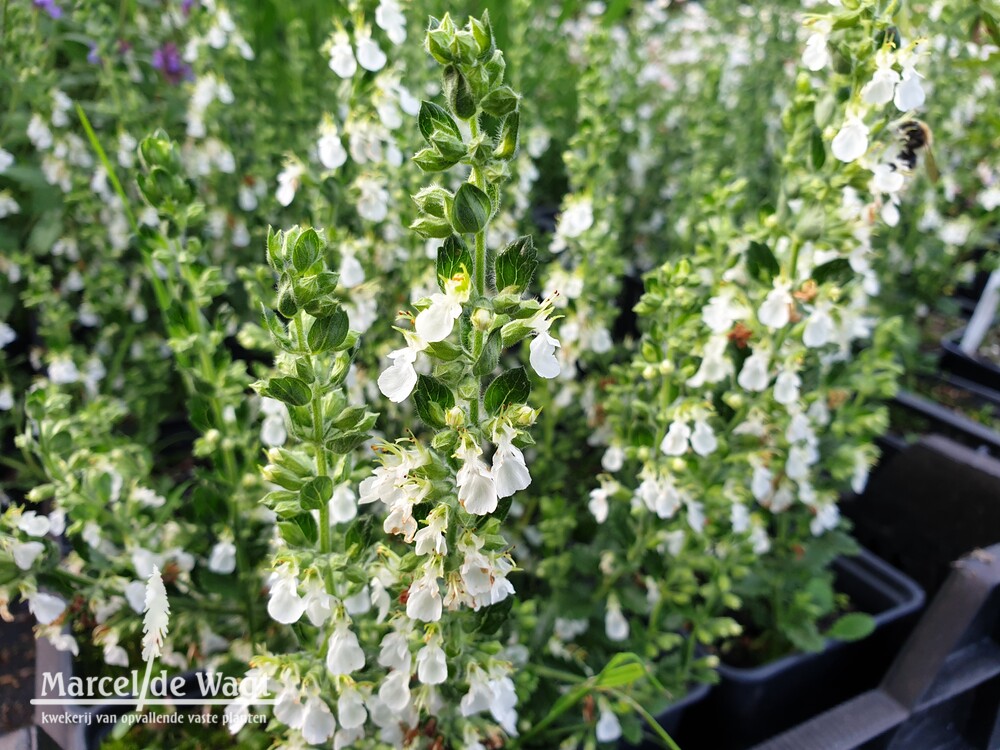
(678, 551), (924, 750)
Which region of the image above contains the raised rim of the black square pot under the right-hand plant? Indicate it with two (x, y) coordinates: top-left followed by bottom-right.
(719, 547), (925, 683)
